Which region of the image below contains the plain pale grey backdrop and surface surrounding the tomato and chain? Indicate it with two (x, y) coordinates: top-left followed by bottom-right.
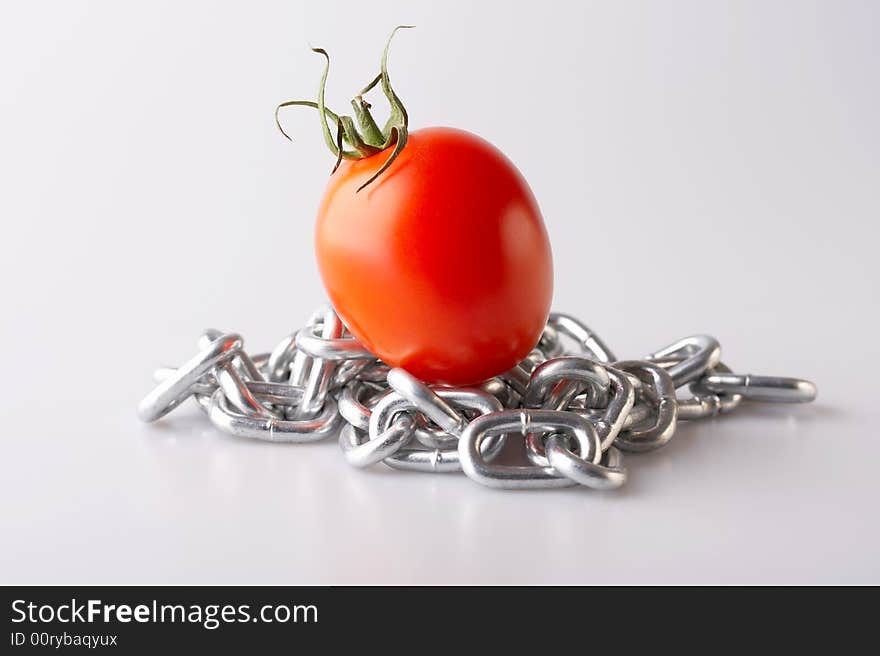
(0, 2), (880, 583)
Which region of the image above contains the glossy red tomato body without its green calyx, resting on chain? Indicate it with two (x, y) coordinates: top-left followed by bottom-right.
(315, 128), (553, 385)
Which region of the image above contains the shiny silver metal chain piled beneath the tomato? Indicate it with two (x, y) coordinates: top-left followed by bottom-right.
(138, 307), (816, 490)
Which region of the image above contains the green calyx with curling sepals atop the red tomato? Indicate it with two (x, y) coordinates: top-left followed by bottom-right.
(275, 25), (414, 191)
